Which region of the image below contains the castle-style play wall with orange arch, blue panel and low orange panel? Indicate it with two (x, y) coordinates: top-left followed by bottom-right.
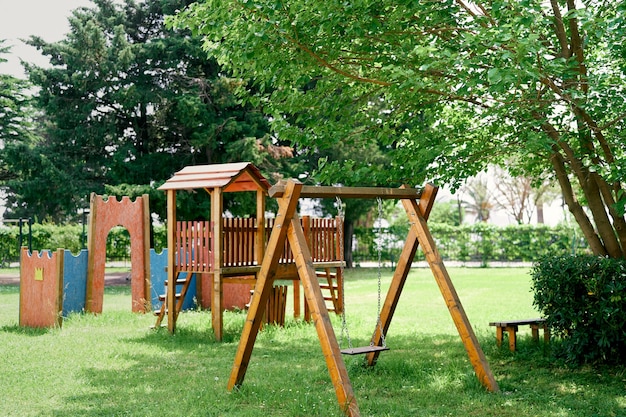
(20, 190), (150, 327)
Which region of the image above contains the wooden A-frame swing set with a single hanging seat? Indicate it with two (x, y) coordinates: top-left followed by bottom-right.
(228, 179), (499, 417)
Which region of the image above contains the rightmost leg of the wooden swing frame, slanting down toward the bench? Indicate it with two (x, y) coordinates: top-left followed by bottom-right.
(402, 200), (499, 391)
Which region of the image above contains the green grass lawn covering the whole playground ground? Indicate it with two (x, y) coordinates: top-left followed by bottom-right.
(0, 268), (626, 417)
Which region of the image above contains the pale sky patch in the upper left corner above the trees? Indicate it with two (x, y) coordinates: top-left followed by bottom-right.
(0, 0), (92, 78)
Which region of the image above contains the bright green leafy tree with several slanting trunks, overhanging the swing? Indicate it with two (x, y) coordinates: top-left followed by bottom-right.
(174, 0), (626, 257)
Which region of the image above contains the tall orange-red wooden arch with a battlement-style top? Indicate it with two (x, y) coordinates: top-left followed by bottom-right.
(85, 193), (151, 313)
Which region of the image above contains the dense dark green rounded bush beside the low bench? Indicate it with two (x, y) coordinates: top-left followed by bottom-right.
(531, 255), (626, 363)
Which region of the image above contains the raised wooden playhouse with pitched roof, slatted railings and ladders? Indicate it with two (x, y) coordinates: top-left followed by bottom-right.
(155, 162), (342, 340)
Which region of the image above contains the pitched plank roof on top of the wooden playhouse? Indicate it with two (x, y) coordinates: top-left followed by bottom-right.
(159, 162), (271, 192)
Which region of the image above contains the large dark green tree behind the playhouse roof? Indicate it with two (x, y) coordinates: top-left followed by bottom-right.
(9, 0), (288, 221)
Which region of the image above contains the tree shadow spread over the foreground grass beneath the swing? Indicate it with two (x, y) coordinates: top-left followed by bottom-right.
(45, 318), (626, 417)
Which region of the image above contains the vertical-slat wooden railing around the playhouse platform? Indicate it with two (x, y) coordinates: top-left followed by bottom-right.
(176, 216), (342, 272)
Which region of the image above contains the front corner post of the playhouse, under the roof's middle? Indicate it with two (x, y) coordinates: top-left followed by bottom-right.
(211, 187), (224, 341)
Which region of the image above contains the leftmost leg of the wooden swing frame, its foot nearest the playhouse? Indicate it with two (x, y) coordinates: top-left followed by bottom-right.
(228, 181), (302, 390)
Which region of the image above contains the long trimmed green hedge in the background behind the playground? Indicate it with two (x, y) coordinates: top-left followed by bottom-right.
(0, 223), (587, 266)
